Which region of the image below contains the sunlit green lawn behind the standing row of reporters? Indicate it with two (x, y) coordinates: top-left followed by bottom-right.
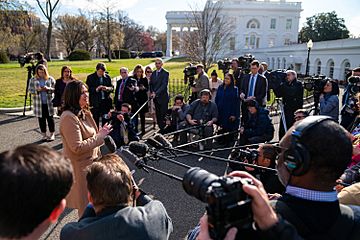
(0, 58), (228, 108)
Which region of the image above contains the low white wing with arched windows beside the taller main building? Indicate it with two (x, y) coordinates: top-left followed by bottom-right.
(248, 38), (360, 80)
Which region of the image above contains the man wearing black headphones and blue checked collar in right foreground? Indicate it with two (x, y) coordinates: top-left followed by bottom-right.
(273, 116), (360, 239)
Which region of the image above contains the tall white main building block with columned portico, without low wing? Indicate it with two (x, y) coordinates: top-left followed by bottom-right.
(166, 0), (301, 56)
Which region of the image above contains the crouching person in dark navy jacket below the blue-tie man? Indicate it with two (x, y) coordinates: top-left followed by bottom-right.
(240, 100), (275, 145)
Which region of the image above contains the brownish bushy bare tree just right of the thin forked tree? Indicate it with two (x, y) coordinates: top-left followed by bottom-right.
(56, 14), (92, 55)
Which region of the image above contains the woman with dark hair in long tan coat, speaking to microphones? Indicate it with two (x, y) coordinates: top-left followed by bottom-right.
(60, 80), (112, 216)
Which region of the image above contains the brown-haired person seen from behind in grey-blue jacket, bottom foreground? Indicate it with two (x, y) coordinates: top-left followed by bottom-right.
(60, 154), (173, 240)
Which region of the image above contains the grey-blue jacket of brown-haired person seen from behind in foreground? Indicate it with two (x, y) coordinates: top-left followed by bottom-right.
(60, 200), (173, 240)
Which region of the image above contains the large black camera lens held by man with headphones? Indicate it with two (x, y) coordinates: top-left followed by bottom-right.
(183, 167), (219, 202)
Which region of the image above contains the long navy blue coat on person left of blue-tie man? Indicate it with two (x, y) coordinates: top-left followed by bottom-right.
(215, 84), (240, 130)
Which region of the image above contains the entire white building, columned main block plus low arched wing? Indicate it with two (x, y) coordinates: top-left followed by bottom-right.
(166, 0), (360, 80)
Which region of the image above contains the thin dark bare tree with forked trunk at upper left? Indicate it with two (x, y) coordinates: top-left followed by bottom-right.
(36, 0), (60, 60)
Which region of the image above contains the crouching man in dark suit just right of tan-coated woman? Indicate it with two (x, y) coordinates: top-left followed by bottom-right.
(108, 103), (140, 148)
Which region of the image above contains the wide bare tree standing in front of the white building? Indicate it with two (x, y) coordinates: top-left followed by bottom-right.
(184, 1), (233, 71)
